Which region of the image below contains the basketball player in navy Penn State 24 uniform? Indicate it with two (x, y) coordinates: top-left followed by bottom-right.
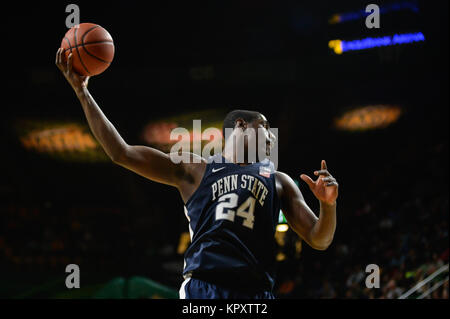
(56, 49), (338, 299)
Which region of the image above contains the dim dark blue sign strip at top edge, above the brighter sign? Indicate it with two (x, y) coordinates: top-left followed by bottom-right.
(328, 1), (419, 24)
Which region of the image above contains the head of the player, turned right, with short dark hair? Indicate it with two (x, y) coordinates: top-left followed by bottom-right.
(222, 110), (275, 161)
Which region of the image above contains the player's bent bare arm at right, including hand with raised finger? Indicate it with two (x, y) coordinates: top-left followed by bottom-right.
(276, 161), (338, 250)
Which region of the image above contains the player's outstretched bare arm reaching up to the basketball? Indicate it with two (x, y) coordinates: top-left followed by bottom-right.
(56, 49), (205, 201)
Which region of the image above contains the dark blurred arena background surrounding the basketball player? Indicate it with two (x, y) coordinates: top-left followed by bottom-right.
(0, 0), (449, 299)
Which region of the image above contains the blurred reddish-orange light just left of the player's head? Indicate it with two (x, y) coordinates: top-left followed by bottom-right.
(141, 109), (226, 155)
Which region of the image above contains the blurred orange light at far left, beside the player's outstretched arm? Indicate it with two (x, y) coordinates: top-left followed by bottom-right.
(16, 120), (107, 162)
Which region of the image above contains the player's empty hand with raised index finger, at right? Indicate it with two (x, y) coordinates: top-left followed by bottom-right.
(300, 160), (339, 205)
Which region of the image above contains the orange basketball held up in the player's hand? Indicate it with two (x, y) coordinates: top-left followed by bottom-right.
(61, 23), (114, 75)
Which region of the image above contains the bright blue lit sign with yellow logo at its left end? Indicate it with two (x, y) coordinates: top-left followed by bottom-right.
(328, 32), (425, 54)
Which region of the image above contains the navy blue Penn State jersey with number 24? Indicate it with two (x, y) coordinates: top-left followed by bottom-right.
(183, 155), (280, 290)
